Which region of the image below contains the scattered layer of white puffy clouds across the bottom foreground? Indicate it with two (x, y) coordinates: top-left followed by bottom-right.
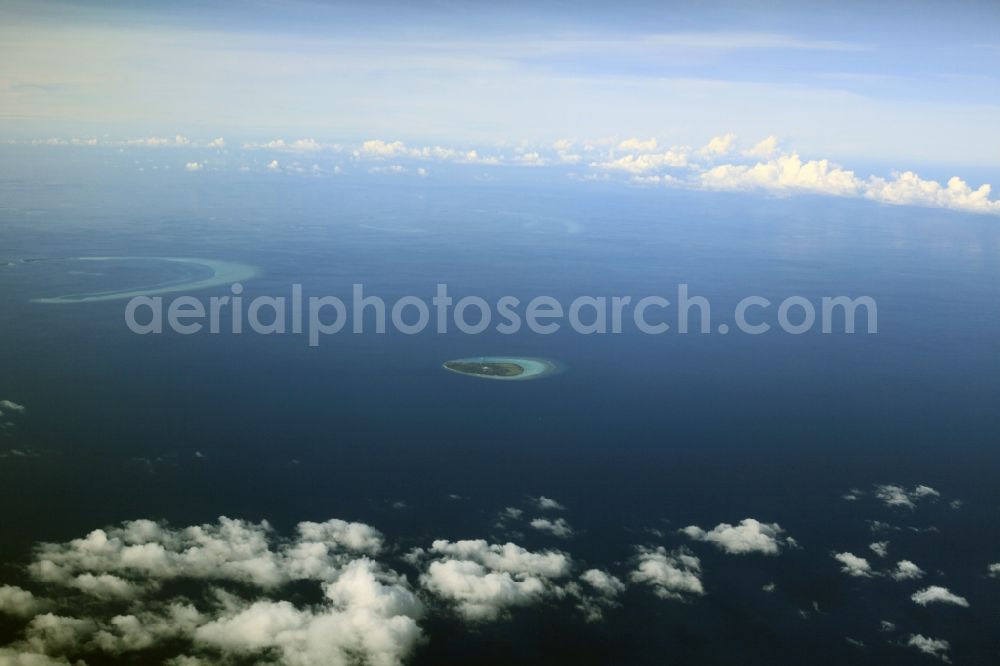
(0, 500), (984, 666)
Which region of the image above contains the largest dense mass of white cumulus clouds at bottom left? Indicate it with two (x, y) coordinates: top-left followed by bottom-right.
(0, 518), (422, 666)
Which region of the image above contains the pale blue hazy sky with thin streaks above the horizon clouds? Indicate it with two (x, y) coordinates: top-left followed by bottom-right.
(0, 0), (1000, 170)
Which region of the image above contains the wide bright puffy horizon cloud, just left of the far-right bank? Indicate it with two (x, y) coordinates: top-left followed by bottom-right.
(699, 152), (863, 196)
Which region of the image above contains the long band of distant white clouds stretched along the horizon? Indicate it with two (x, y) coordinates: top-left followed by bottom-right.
(11, 133), (1000, 214)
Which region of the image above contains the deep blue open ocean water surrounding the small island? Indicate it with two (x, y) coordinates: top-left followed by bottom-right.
(0, 149), (1000, 664)
